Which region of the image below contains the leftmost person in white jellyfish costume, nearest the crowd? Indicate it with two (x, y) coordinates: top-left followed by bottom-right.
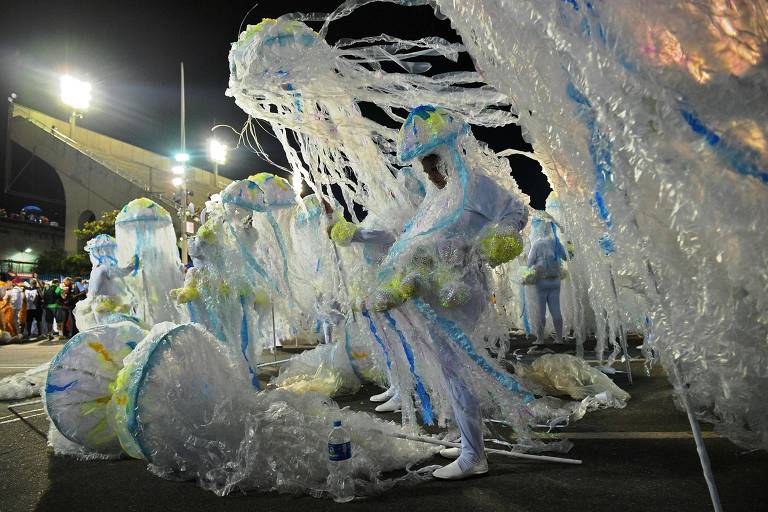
(74, 234), (138, 330)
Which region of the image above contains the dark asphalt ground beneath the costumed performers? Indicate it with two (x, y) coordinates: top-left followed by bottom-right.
(0, 339), (768, 512)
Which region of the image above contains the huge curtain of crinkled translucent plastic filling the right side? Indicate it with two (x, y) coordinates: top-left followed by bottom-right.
(435, 0), (768, 448)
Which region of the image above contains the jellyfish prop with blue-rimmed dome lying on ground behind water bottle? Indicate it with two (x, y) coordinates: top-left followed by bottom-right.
(107, 324), (433, 495)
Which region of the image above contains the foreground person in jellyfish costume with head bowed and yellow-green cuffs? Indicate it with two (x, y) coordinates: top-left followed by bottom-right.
(376, 105), (530, 479)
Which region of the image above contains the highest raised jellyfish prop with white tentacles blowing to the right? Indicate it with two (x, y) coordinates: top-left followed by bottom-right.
(227, 16), (514, 231)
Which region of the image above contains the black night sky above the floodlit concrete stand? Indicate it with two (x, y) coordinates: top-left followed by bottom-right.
(0, 0), (549, 220)
